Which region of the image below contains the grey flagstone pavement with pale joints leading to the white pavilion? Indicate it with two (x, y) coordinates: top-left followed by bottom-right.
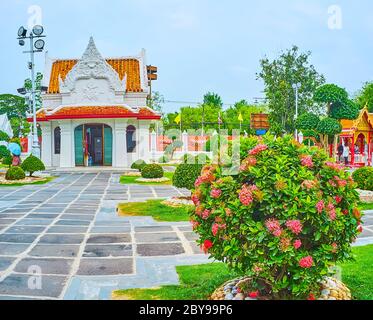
(0, 172), (373, 300)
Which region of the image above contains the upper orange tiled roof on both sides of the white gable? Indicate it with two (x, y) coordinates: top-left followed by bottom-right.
(48, 59), (143, 94)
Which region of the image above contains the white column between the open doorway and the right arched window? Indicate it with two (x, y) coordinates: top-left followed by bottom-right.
(113, 119), (129, 168)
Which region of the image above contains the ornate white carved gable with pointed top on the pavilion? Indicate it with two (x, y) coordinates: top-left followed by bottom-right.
(59, 37), (126, 104)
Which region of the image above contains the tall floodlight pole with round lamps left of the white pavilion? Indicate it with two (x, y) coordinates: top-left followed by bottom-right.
(17, 25), (45, 158)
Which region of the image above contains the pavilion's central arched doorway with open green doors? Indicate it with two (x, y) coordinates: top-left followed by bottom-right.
(74, 124), (113, 167)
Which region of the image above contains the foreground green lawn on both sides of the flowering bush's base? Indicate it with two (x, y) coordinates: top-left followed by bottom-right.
(113, 245), (373, 300)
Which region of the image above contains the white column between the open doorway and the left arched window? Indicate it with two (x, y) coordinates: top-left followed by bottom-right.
(60, 120), (75, 168)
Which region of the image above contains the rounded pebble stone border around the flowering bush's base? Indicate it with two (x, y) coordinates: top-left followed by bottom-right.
(210, 277), (352, 300)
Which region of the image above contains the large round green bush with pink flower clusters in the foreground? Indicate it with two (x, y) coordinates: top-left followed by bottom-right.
(191, 136), (361, 299)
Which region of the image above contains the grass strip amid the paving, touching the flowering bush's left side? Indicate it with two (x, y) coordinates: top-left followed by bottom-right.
(118, 200), (191, 222)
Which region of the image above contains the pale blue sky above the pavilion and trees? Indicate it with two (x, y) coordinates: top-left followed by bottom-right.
(0, 0), (373, 111)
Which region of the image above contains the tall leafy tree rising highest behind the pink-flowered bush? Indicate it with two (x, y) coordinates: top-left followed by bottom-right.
(257, 46), (325, 132)
